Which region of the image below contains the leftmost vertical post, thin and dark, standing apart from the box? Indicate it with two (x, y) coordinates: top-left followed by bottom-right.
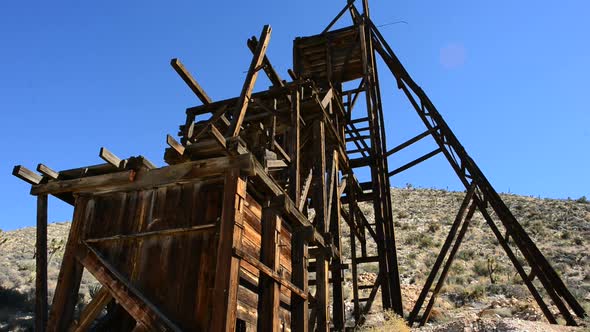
(35, 195), (47, 331)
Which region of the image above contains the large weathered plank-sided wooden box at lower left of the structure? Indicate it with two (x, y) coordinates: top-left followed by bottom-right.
(32, 154), (310, 331)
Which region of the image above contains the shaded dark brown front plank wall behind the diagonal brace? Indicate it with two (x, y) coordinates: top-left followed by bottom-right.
(78, 182), (223, 331)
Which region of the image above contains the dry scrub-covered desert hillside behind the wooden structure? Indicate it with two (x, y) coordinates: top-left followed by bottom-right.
(0, 186), (590, 331)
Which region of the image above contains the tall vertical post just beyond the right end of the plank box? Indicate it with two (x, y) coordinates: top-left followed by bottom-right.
(312, 120), (330, 331)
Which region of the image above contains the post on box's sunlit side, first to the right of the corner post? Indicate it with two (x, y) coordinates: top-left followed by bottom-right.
(258, 206), (281, 331)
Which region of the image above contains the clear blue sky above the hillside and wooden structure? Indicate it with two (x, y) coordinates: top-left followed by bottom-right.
(0, 0), (590, 230)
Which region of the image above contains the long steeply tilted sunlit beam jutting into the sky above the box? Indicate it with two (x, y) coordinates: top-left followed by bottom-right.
(229, 25), (272, 137)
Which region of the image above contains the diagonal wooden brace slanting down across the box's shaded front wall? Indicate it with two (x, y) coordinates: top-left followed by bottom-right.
(77, 244), (182, 332)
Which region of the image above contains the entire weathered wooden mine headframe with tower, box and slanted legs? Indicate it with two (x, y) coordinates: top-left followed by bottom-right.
(13, 1), (585, 331)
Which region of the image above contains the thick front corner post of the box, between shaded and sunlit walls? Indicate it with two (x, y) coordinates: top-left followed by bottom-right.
(209, 168), (246, 332)
